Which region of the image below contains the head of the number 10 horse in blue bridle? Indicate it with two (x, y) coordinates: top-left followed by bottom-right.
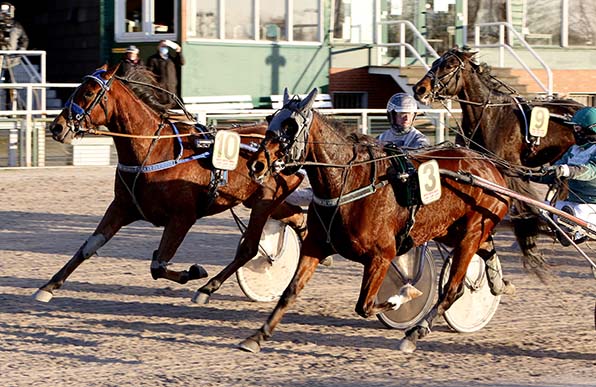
(50, 65), (119, 144)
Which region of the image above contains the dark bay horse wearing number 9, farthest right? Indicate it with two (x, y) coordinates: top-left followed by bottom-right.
(414, 48), (583, 277)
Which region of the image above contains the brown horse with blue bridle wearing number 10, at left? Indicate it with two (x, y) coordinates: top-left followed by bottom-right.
(35, 66), (305, 302)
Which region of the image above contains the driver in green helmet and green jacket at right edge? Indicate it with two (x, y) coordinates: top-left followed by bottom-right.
(529, 107), (596, 204)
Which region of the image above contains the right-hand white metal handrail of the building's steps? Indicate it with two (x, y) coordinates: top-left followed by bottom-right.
(474, 22), (553, 97)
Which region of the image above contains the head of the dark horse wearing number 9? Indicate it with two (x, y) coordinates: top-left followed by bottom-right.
(414, 48), (476, 105)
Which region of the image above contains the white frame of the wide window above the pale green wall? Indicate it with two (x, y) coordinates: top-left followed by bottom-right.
(186, 0), (325, 46)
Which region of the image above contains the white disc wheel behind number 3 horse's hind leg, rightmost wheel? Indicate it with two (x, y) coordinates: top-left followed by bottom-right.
(440, 254), (501, 333)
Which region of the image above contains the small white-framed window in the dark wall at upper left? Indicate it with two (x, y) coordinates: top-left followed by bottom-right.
(114, 0), (178, 42)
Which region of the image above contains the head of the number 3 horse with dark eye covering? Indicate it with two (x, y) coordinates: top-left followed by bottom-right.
(248, 89), (318, 181)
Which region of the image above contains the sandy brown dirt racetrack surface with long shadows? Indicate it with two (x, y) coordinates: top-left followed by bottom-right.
(0, 167), (596, 387)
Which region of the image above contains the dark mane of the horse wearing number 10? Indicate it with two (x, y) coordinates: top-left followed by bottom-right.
(119, 66), (173, 114)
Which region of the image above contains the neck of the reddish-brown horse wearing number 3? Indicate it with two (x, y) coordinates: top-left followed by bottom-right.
(305, 114), (369, 198)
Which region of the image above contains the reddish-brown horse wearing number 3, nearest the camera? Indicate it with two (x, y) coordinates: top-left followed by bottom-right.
(240, 89), (509, 352)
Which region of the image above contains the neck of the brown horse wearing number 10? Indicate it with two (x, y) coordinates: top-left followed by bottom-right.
(107, 81), (174, 165)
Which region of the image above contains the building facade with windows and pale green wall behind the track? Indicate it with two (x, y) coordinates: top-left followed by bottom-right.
(16, 0), (596, 107)
